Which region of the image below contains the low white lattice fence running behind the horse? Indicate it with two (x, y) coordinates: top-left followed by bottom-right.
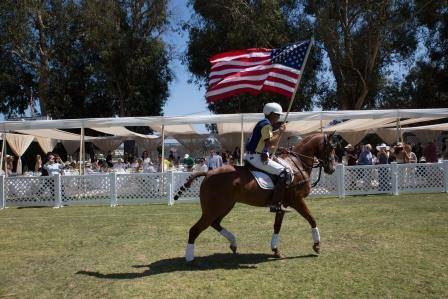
(0, 161), (448, 208)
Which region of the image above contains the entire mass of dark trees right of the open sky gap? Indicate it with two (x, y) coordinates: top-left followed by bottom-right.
(186, 0), (448, 113)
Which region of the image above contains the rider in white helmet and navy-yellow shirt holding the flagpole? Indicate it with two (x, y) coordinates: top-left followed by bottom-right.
(244, 103), (290, 213)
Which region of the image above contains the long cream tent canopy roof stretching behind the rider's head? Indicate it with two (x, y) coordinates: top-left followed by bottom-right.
(0, 108), (448, 173)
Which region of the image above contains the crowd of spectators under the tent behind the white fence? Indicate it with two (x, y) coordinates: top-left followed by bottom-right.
(0, 138), (448, 175)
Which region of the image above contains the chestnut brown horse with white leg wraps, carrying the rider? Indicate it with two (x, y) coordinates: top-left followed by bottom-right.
(174, 133), (335, 262)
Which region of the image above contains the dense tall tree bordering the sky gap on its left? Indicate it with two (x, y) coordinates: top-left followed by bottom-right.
(79, 0), (172, 116)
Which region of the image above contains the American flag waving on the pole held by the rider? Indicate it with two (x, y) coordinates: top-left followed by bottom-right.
(206, 40), (312, 102)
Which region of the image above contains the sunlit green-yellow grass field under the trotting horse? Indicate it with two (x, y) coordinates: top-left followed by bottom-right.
(0, 194), (448, 298)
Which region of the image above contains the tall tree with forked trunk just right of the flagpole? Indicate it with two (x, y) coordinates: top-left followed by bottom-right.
(304, 0), (417, 109)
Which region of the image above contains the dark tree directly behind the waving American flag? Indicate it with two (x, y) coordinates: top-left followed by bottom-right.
(185, 0), (321, 113)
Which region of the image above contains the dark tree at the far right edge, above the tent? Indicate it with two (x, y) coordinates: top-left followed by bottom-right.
(380, 0), (448, 108)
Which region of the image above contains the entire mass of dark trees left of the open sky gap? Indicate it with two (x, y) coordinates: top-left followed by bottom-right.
(0, 0), (172, 117)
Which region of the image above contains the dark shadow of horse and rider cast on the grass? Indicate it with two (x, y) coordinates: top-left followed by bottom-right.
(76, 253), (317, 279)
